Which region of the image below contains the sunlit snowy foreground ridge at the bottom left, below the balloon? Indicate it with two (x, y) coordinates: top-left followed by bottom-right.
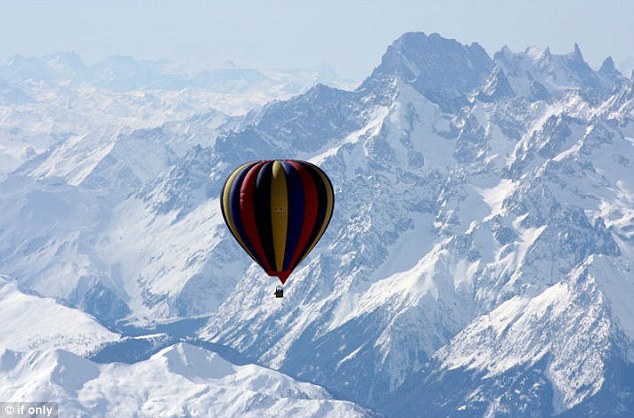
(0, 343), (369, 418)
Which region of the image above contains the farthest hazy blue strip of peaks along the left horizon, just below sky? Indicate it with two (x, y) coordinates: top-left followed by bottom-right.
(0, 52), (346, 94)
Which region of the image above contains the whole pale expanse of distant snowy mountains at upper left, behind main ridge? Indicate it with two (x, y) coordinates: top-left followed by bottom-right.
(0, 53), (343, 176)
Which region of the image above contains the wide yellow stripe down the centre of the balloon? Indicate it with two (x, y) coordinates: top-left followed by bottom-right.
(271, 161), (288, 271)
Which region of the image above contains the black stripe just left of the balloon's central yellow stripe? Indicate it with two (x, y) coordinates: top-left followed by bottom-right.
(253, 161), (276, 271)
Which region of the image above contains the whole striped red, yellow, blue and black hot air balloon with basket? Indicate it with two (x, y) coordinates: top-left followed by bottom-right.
(220, 160), (335, 297)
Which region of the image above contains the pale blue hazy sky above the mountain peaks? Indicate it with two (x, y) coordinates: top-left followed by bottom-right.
(0, 0), (634, 80)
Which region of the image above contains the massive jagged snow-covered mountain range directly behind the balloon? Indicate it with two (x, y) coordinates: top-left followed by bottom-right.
(0, 33), (634, 417)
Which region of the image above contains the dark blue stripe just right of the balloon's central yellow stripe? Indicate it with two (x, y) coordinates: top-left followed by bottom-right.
(282, 162), (305, 271)
